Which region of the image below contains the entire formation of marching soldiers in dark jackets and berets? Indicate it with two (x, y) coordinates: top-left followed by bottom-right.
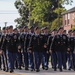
(0, 26), (75, 73)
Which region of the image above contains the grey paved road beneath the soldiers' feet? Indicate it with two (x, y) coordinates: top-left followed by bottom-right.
(0, 69), (75, 75)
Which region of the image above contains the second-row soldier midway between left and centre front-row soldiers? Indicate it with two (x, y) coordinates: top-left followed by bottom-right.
(20, 26), (30, 70)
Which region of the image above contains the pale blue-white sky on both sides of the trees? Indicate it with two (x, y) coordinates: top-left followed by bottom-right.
(0, 0), (75, 27)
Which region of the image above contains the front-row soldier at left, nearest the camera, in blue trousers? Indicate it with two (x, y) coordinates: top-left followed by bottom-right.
(4, 26), (18, 73)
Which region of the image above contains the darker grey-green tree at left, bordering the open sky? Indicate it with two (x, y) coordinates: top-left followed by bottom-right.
(14, 0), (29, 26)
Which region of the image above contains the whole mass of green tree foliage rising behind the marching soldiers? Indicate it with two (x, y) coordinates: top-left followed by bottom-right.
(15, 0), (72, 29)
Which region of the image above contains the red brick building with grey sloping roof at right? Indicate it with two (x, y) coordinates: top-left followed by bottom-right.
(62, 7), (75, 32)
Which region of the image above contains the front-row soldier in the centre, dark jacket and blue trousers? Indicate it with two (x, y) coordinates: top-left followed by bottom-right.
(29, 27), (44, 72)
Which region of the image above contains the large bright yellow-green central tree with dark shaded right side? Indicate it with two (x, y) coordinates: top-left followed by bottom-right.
(23, 0), (58, 25)
